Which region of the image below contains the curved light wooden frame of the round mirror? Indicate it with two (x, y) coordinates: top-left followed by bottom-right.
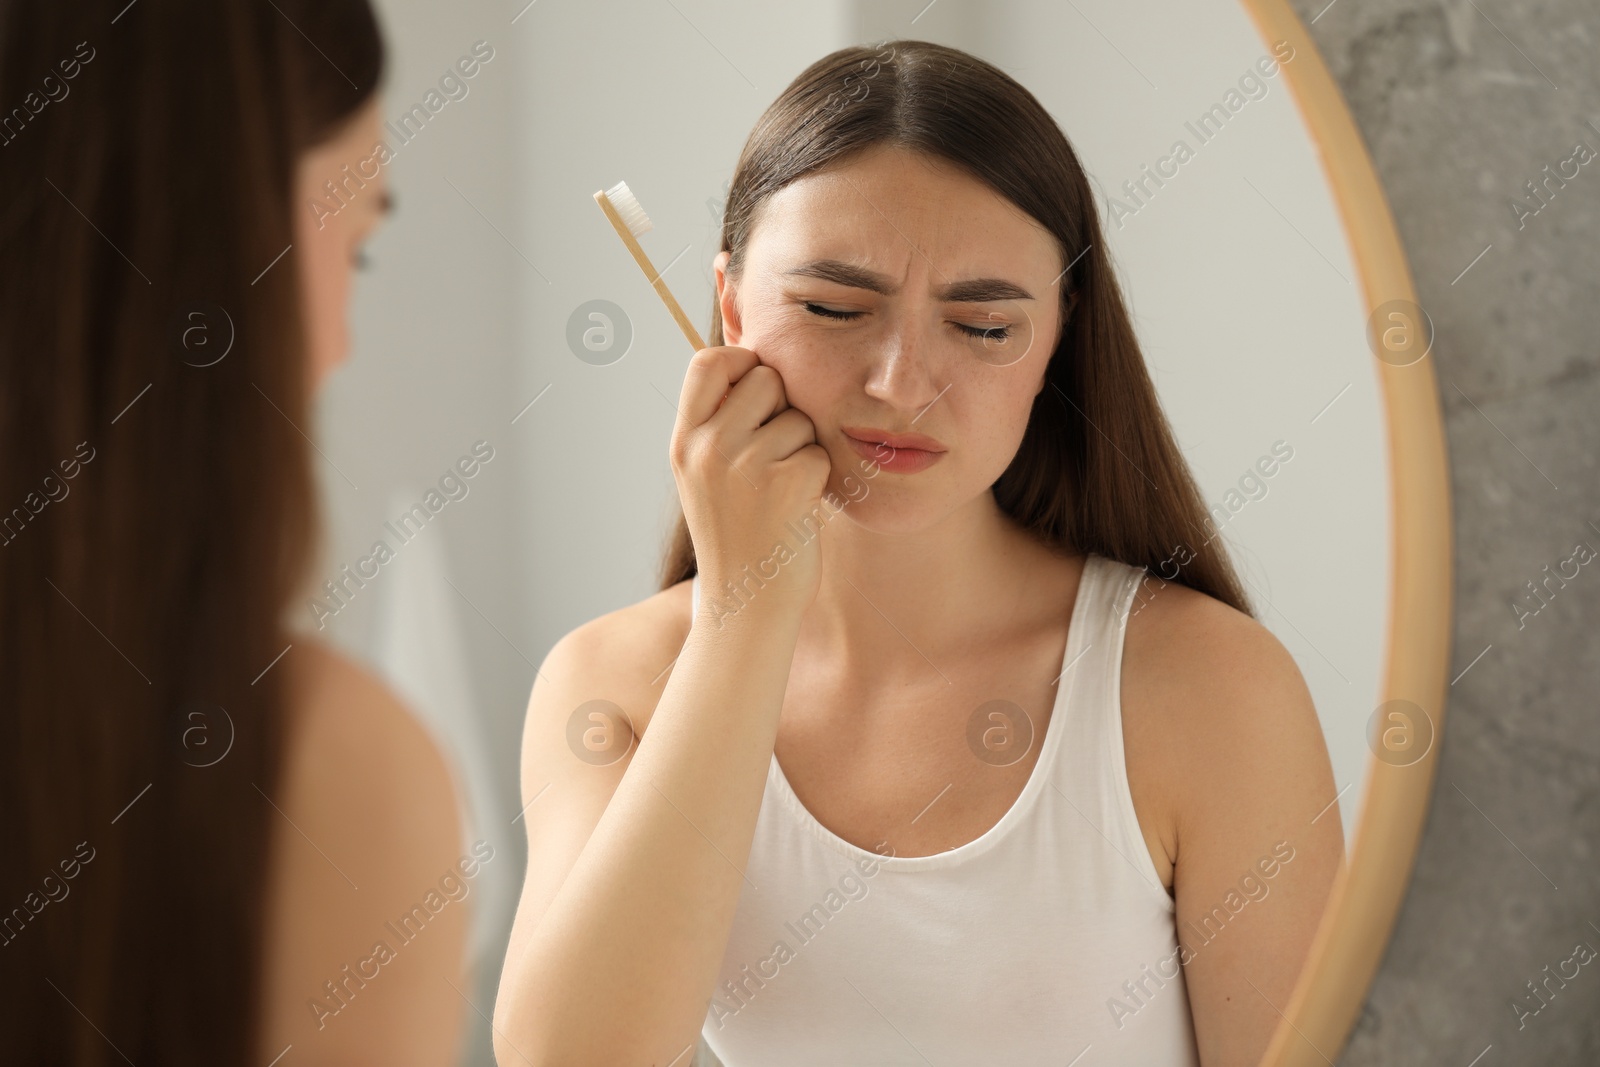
(1245, 0), (1454, 1067)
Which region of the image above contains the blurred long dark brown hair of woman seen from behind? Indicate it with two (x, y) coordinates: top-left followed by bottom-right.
(0, 0), (382, 1067)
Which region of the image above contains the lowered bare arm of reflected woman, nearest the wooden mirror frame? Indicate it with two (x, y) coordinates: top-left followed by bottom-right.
(1123, 587), (1344, 1067)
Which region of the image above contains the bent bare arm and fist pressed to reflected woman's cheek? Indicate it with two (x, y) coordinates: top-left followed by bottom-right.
(494, 347), (829, 1067)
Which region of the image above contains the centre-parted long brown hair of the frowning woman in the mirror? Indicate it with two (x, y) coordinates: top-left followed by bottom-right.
(661, 40), (1251, 614)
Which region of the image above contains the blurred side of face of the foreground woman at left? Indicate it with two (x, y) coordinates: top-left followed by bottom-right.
(294, 99), (389, 392)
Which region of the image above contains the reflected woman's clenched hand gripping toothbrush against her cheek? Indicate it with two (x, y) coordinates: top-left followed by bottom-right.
(669, 346), (832, 611)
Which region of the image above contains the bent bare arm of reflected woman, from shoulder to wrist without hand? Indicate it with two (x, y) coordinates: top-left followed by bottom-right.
(494, 605), (798, 1067)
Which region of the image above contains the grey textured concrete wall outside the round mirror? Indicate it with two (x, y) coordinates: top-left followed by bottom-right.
(1294, 0), (1600, 1067)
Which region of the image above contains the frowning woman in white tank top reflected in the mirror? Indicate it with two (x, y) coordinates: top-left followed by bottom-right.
(496, 42), (1342, 1067)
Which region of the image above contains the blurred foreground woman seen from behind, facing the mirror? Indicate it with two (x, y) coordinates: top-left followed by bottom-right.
(0, 0), (466, 1065)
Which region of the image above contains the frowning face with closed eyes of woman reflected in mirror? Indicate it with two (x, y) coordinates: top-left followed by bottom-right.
(715, 147), (1066, 533)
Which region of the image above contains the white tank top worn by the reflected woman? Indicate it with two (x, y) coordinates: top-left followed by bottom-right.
(693, 553), (1200, 1067)
